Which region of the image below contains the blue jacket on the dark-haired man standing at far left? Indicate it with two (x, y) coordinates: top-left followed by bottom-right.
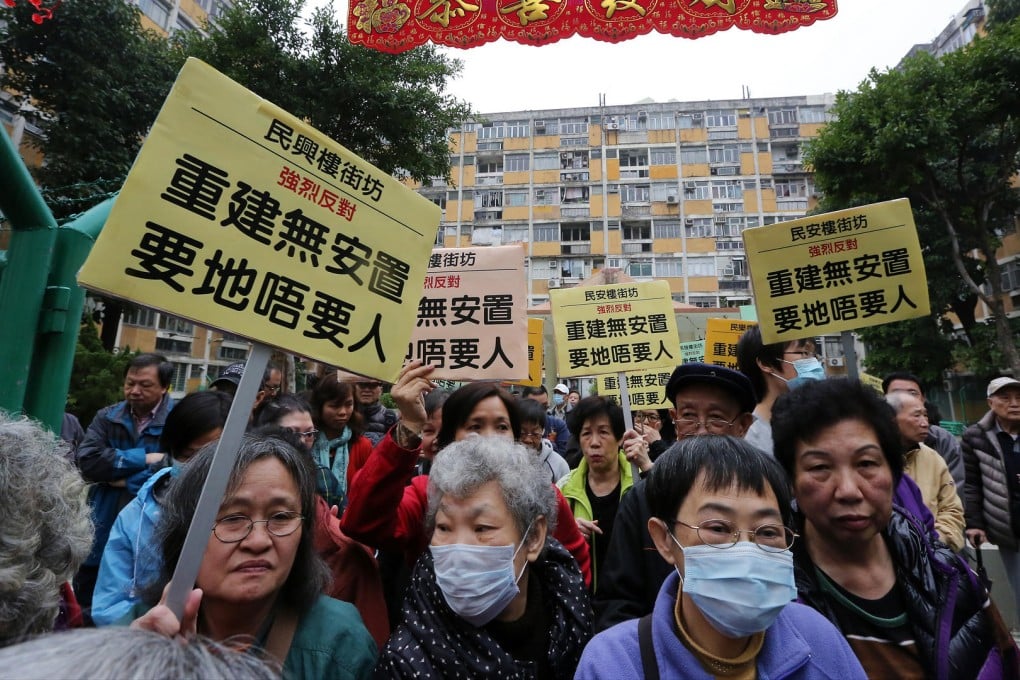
(74, 395), (173, 567)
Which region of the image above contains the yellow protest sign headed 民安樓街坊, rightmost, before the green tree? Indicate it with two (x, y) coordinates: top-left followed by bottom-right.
(744, 199), (929, 344)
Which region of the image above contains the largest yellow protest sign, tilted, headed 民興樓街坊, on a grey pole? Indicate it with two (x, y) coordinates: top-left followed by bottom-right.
(79, 59), (440, 380)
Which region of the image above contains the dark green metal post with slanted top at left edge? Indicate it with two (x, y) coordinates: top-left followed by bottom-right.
(0, 126), (57, 412)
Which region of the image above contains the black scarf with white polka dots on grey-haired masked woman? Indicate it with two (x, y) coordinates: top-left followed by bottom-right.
(375, 537), (593, 680)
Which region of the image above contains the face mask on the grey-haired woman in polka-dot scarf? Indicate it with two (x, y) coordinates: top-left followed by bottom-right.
(428, 525), (531, 626)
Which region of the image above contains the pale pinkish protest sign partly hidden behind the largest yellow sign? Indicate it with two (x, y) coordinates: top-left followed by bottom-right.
(408, 246), (541, 380)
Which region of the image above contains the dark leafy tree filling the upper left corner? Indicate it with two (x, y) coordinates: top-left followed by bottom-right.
(0, 0), (176, 350)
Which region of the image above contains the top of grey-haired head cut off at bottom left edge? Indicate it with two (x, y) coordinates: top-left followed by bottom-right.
(0, 626), (279, 680)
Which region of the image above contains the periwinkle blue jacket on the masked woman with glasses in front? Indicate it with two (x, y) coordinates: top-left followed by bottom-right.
(574, 571), (866, 680)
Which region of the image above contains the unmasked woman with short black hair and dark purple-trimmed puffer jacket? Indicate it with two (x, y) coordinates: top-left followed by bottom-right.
(772, 380), (1017, 680)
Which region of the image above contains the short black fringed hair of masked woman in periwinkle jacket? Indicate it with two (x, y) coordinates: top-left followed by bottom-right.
(645, 434), (793, 525)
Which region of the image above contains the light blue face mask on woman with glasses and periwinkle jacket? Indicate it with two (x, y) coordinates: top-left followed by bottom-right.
(669, 533), (797, 637)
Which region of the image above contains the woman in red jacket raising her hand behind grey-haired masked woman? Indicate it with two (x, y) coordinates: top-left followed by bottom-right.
(341, 361), (591, 581)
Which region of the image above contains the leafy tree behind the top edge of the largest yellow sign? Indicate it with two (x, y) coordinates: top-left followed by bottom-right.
(176, 0), (470, 181)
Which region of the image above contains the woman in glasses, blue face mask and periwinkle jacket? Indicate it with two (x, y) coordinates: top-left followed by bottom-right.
(575, 436), (865, 680)
